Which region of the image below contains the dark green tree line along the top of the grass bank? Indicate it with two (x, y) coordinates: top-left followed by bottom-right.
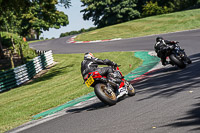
(60, 0), (200, 37)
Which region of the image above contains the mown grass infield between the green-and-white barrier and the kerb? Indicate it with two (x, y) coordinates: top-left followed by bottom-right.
(0, 52), (142, 132)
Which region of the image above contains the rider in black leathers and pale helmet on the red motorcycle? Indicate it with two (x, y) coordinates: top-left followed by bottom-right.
(81, 52), (127, 95)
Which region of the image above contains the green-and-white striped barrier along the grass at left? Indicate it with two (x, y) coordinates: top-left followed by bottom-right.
(0, 50), (54, 92)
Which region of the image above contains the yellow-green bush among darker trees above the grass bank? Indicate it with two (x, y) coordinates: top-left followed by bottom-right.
(142, 1), (169, 16)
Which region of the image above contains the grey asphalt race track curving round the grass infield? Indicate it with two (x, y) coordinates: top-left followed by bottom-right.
(11, 30), (200, 133)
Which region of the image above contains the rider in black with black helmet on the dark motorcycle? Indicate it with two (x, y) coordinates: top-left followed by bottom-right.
(154, 36), (178, 66)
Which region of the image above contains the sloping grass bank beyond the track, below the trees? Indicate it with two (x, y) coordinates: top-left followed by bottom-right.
(75, 9), (200, 41)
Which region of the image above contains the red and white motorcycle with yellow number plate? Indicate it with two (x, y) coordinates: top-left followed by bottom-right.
(84, 65), (135, 106)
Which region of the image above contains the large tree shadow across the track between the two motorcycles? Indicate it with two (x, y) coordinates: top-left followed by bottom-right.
(134, 54), (200, 100)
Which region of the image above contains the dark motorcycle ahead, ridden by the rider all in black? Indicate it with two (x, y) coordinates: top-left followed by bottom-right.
(167, 42), (192, 69)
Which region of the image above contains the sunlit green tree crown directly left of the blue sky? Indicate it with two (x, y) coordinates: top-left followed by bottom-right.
(19, 1), (69, 39)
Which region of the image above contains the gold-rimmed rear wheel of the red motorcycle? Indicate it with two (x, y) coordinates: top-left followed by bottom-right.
(94, 83), (117, 106)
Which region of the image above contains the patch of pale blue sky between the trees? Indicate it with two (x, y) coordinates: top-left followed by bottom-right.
(40, 0), (95, 39)
